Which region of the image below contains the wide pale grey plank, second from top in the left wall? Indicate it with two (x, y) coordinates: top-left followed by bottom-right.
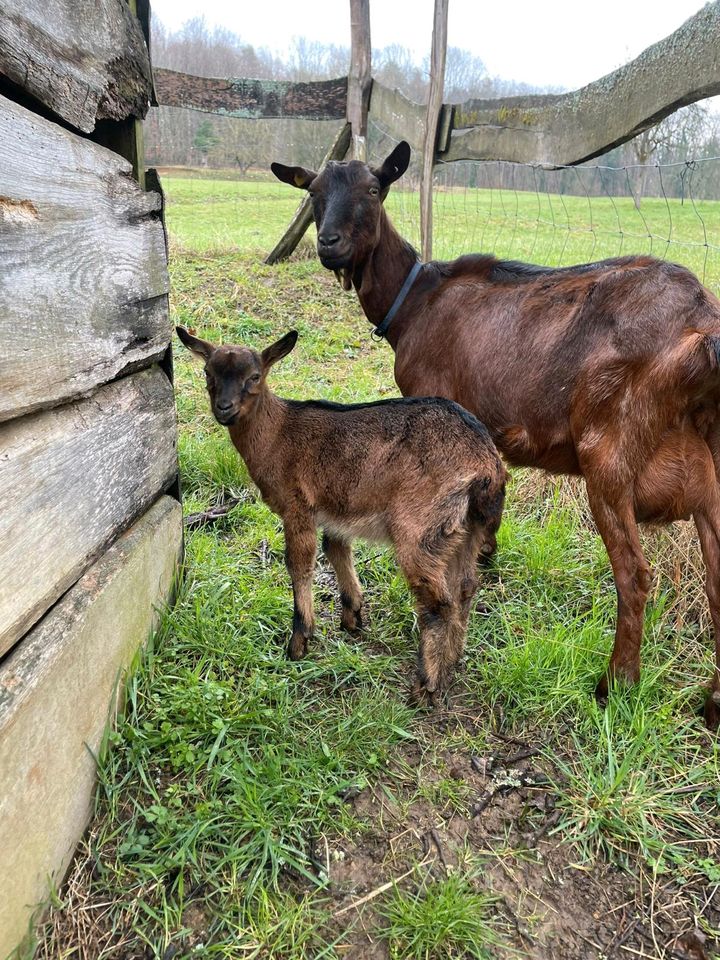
(0, 97), (170, 421)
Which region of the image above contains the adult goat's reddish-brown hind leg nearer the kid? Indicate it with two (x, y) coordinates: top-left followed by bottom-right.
(587, 481), (651, 700)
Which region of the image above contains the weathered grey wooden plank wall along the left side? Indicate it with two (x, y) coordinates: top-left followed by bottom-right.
(0, 0), (182, 958)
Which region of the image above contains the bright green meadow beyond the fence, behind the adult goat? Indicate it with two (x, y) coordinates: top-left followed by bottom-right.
(164, 167), (720, 292)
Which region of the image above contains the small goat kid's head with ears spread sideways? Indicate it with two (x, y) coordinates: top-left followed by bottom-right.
(175, 327), (298, 427)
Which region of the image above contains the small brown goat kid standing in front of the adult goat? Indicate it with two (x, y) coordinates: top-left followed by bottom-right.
(177, 327), (506, 701)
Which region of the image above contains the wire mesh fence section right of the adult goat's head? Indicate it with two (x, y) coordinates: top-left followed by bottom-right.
(370, 116), (720, 292)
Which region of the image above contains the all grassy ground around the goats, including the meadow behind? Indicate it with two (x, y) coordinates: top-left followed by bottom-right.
(29, 172), (720, 960)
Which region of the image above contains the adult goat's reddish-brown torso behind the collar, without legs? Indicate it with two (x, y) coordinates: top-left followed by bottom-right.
(395, 256), (720, 472)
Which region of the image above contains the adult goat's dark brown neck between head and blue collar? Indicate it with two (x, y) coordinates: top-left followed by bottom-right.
(352, 210), (417, 338)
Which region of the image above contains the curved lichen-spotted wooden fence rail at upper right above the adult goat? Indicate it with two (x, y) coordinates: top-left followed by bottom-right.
(443, 0), (720, 164)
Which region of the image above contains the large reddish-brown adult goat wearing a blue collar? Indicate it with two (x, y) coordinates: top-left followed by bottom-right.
(272, 142), (720, 729)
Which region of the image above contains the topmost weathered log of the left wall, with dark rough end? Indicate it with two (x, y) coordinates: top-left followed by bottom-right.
(0, 0), (152, 133)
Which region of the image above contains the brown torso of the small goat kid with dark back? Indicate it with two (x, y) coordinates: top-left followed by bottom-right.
(239, 398), (505, 539)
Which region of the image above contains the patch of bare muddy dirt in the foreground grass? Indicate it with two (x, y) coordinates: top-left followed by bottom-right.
(316, 720), (720, 960)
